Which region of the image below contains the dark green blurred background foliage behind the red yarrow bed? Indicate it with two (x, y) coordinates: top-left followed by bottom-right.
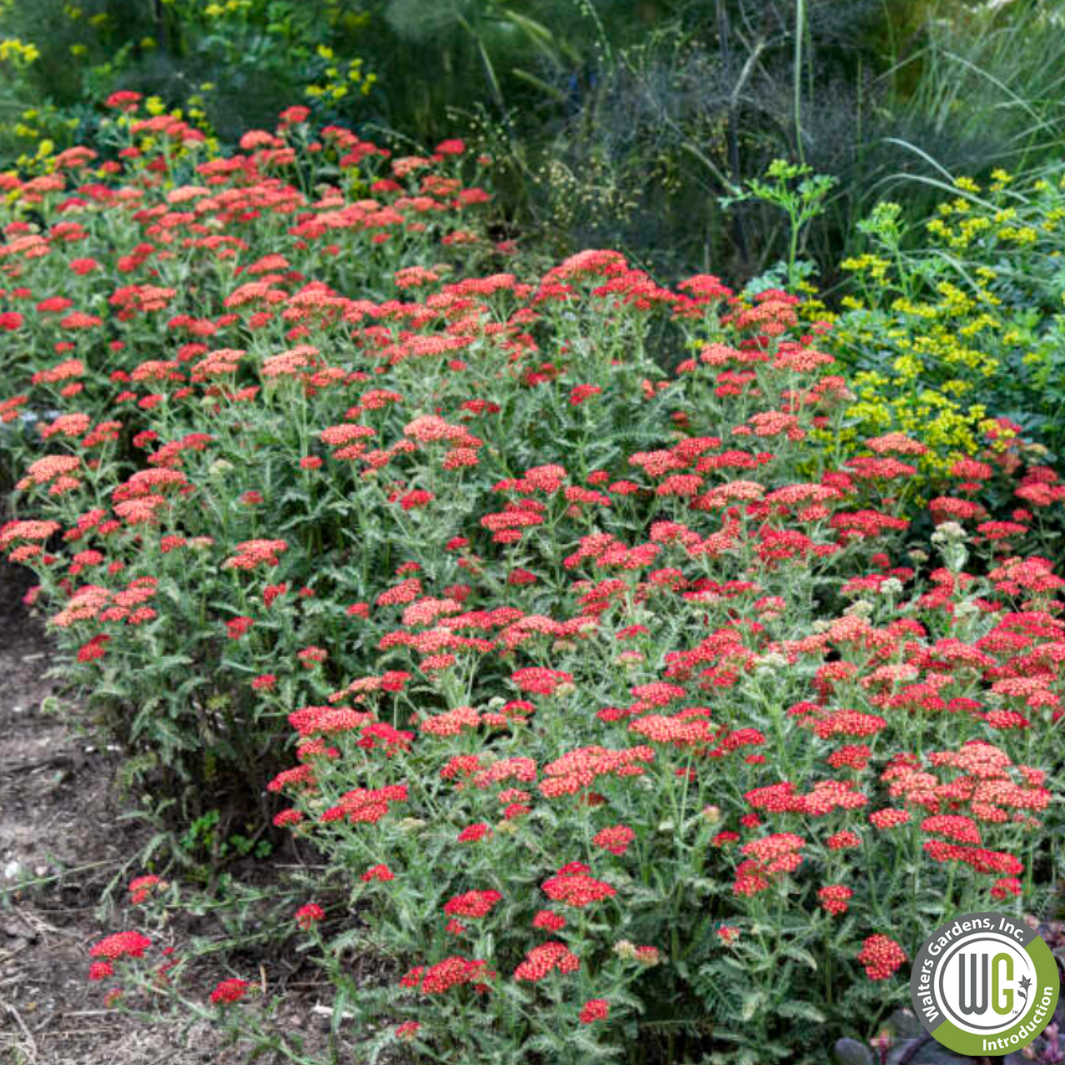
(6, 0), (1065, 282)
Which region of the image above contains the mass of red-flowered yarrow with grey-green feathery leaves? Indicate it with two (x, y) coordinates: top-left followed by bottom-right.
(6, 100), (1065, 1065)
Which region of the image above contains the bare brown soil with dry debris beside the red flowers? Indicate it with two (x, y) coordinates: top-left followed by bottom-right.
(0, 562), (342, 1065)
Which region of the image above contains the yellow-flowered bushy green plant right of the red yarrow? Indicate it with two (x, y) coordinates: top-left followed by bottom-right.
(833, 170), (1065, 474)
